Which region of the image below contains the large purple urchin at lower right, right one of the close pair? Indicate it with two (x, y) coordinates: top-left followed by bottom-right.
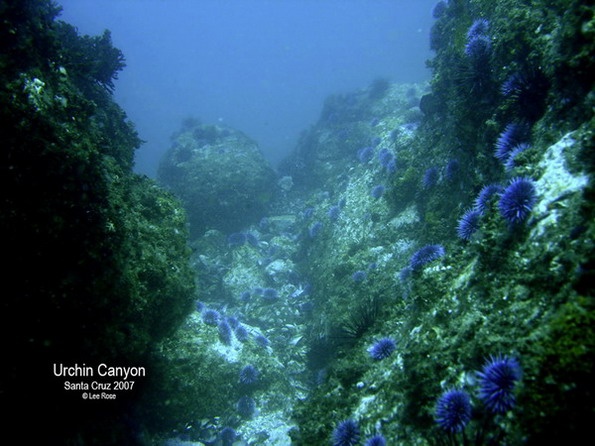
(477, 355), (521, 413)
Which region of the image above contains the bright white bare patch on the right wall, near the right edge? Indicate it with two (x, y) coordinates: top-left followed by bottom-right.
(531, 133), (589, 236)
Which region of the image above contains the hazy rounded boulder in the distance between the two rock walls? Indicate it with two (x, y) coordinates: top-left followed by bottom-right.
(158, 122), (276, 236)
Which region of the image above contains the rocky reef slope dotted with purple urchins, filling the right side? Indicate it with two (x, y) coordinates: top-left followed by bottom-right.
(151, 0), (595, 445)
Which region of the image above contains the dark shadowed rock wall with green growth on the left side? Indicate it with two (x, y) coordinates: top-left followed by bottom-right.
(0, 0), (194, 444)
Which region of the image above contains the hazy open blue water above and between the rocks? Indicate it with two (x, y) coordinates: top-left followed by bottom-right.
(58, 0), (437, 176)
